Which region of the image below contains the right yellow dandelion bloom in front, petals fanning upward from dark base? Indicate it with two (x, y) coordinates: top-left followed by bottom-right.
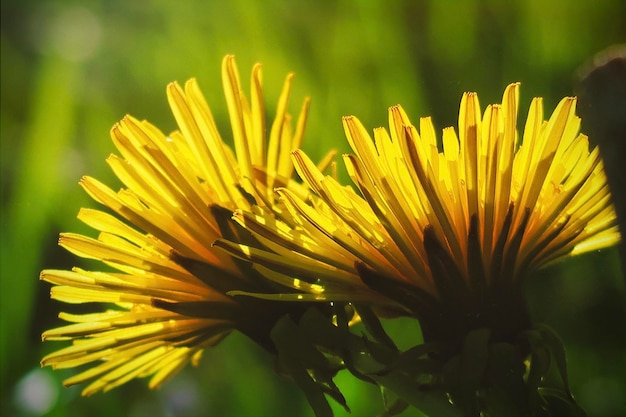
(216, 84), (620, 342)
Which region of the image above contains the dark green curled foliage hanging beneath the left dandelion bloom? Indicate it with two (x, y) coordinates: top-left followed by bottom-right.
(272, 308), (461, 417)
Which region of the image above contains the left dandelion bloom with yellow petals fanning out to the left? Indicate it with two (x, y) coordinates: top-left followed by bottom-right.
(41, 56), (320, 395)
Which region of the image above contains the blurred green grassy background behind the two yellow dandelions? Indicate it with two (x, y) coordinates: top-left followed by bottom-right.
(0, 0), (626, 416)
